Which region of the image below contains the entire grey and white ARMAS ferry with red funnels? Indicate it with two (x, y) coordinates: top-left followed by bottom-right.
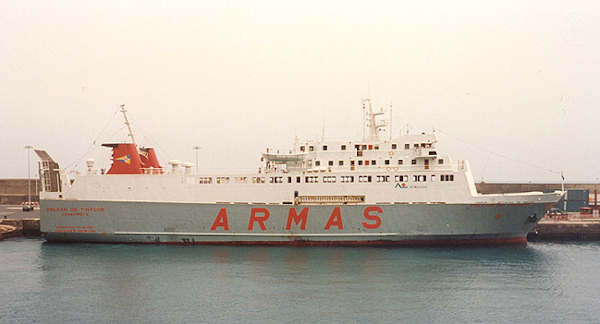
(36, 99), (563, 246)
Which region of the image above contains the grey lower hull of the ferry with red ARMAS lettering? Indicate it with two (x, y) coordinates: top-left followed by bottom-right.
(41, 200), (553, 245)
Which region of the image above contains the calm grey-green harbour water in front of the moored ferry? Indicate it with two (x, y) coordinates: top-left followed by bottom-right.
(0, 238), (600, 323)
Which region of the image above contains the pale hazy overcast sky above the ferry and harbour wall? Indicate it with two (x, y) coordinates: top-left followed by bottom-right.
(0, 0), (600, 182)
